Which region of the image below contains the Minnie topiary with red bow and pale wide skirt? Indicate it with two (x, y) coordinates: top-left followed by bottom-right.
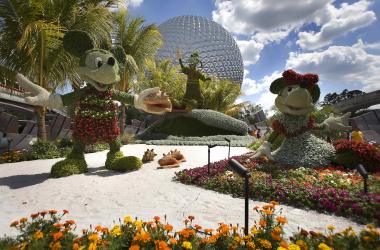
(253, 70), (351, 167)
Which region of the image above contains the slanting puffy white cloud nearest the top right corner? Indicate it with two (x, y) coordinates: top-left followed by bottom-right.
(297, 0), (376, 50)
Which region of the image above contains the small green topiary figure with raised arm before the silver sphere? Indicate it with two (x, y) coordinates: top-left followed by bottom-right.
(177, 51), (210, 109)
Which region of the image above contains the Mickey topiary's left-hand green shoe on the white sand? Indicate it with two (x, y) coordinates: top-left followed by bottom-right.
(50, 159), (87, 178)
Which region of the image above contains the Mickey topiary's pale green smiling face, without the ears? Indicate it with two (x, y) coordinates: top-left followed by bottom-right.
(78, 49), (120, 91)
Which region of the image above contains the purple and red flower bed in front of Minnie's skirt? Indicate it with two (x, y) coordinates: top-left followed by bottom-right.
(174, 155), (380, 225)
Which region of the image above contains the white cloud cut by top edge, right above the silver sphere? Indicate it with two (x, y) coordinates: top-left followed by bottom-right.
(212, 0), (333, 35)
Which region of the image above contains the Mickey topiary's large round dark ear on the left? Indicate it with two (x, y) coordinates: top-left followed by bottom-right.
(63, 30), (94, 57)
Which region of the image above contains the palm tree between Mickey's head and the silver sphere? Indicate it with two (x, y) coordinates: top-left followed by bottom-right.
(114, 8), (162, 131)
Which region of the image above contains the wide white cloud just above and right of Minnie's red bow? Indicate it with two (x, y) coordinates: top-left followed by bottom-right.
(286, 41), (380, 92)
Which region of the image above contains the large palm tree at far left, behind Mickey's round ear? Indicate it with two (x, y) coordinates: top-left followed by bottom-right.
(0, 0), (114, 140)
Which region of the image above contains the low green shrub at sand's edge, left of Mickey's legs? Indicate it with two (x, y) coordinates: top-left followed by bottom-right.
(25, 140), (64, 160)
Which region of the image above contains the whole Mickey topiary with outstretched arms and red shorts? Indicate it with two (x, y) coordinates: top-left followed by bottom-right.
(16, 31), (171, 177)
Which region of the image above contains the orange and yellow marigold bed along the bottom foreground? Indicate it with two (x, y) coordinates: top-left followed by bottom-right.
(0, 201), (380, 250)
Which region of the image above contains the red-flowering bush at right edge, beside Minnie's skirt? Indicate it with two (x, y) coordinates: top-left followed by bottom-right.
(334, 139), (380, 172)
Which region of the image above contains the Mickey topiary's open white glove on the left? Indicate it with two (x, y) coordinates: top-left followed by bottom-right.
(16, 74), (63, 109)
